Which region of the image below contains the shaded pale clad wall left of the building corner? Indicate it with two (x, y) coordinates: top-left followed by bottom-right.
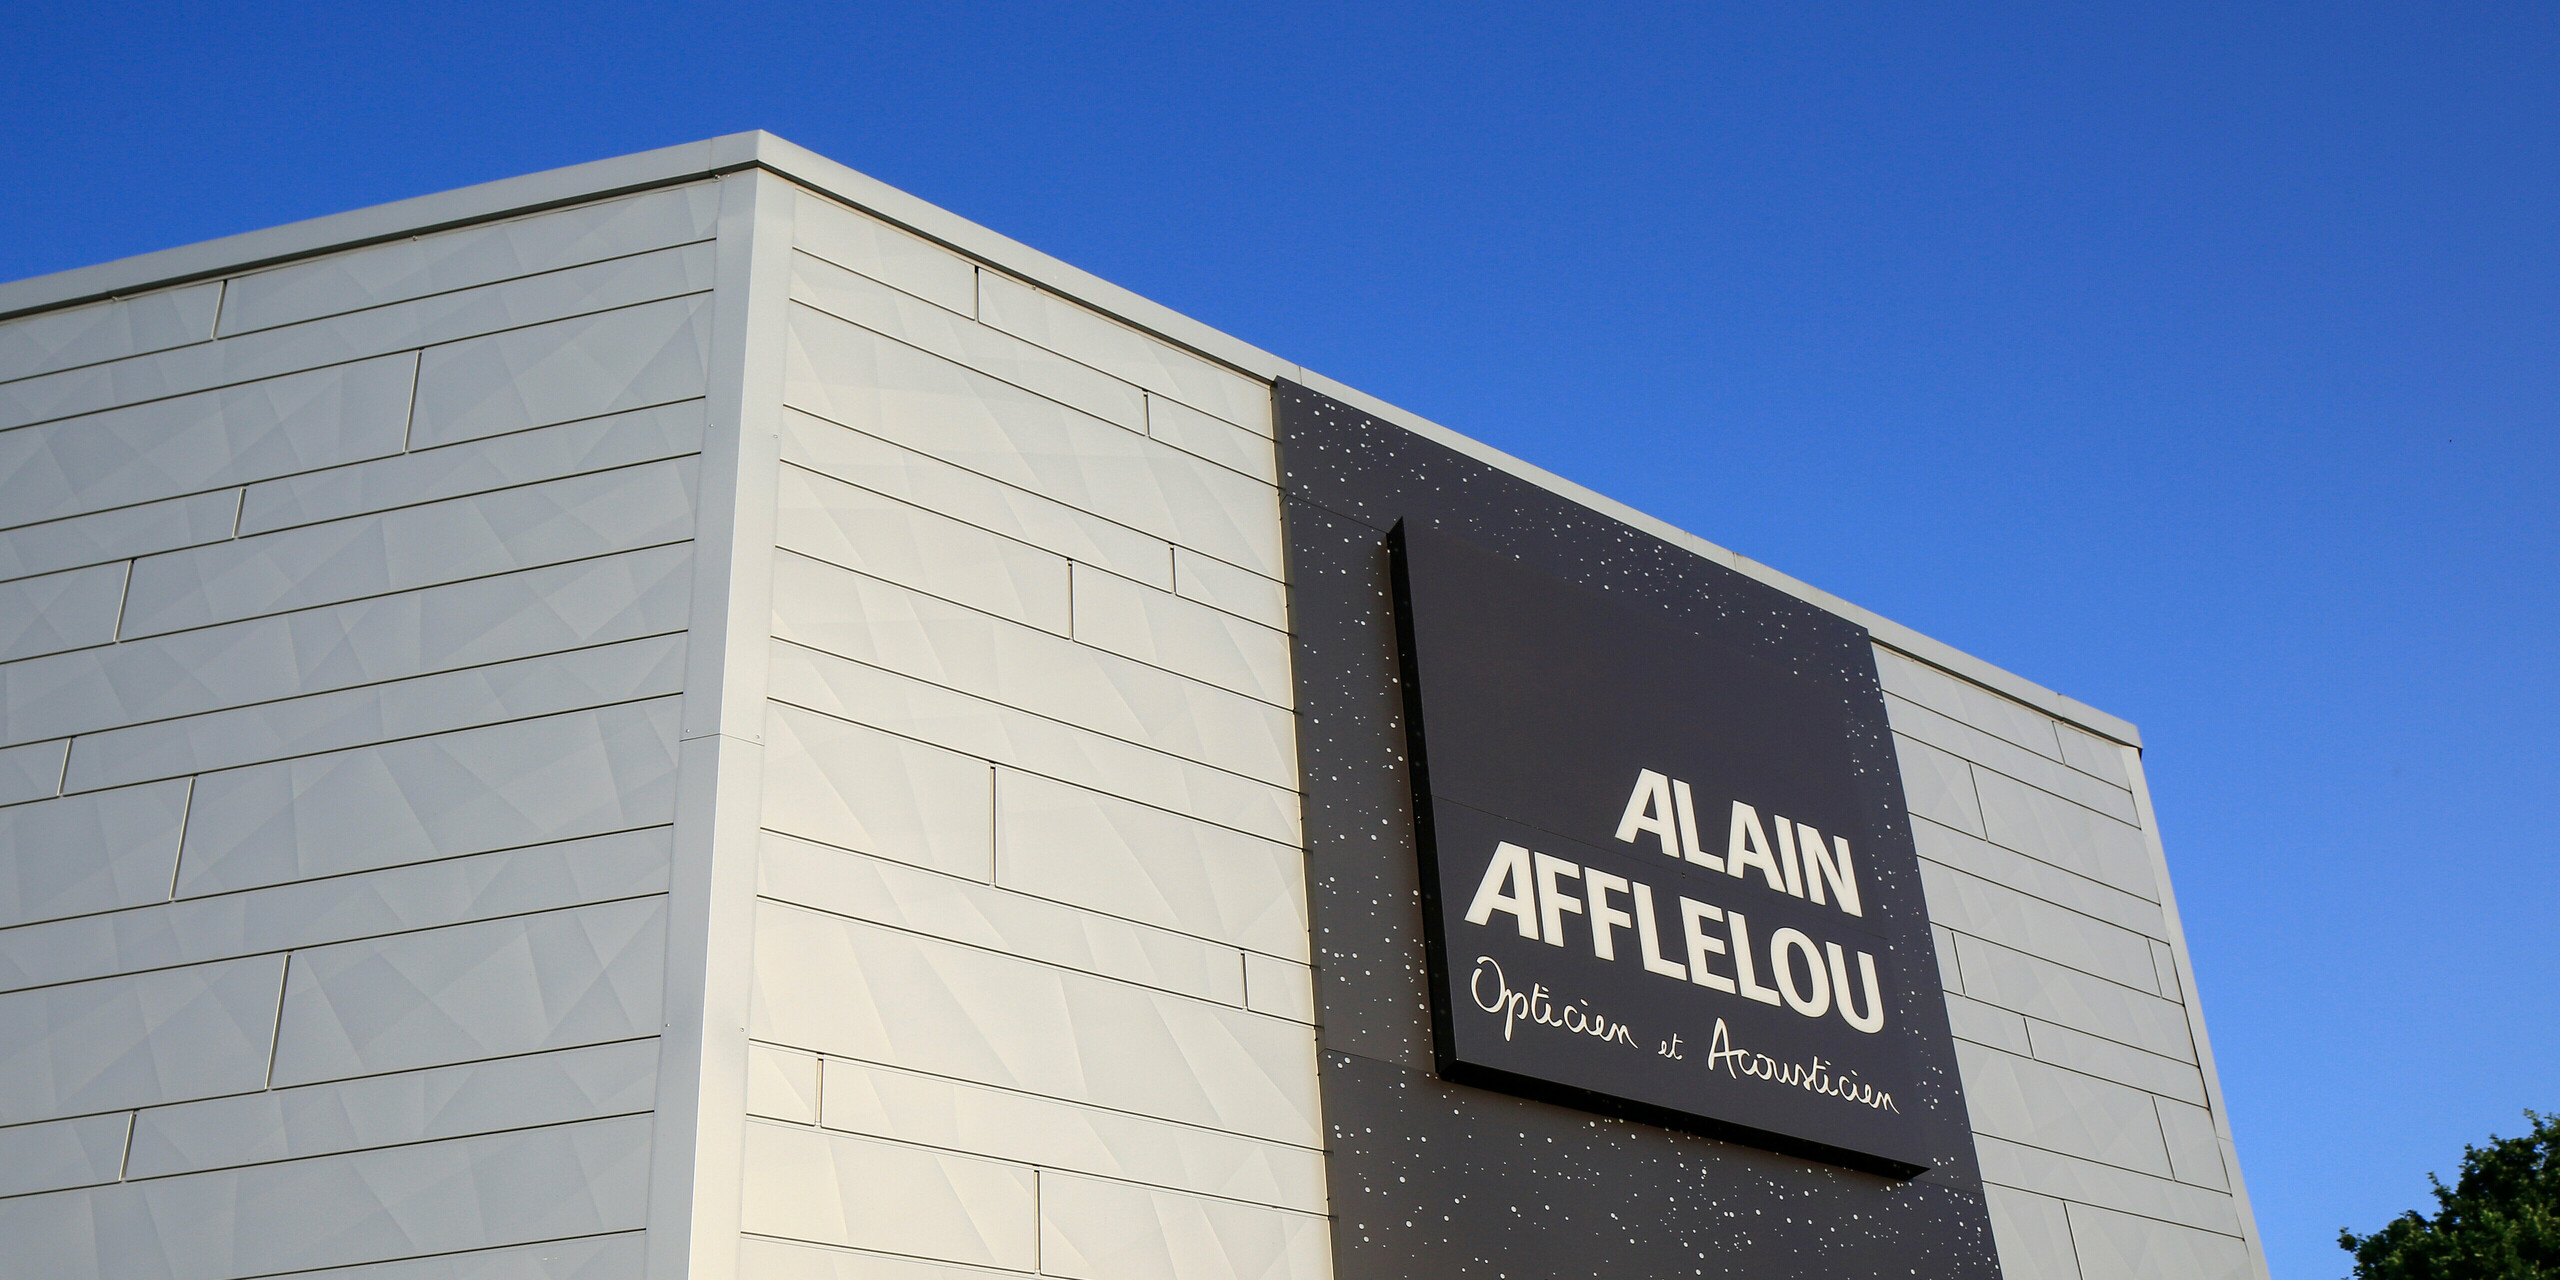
(0, 184), (719, 1280)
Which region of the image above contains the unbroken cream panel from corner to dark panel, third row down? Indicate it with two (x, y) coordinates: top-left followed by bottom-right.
(783, 307), (1280, 579)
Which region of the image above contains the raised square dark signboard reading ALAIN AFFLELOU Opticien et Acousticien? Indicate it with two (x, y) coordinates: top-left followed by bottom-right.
(1395, 517), (1935, 1175)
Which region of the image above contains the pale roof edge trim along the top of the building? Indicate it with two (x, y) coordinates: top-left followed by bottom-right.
(0, 131), (2143, 748)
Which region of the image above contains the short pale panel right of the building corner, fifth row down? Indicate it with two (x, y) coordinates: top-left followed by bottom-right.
(773, 466), (1068, 635)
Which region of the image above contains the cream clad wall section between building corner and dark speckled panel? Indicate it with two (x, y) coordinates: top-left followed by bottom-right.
(740, 195), (1331, 1280)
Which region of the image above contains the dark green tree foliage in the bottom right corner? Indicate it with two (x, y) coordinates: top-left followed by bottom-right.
(2337, 1111), (2560, 1280)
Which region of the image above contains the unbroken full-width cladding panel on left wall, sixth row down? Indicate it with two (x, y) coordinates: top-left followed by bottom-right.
(0, 545), (694, 742)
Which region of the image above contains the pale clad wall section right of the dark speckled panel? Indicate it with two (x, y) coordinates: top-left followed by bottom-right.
(1876, 648), (2266, 1280)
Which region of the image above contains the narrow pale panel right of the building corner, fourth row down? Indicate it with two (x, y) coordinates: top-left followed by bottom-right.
(781, 410), (1177, 586)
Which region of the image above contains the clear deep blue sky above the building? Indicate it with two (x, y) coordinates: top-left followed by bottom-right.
(0, 0), (2560, 1277)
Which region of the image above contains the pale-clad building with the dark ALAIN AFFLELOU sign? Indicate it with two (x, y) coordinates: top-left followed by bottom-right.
(0, 133), (2266, 1280)
